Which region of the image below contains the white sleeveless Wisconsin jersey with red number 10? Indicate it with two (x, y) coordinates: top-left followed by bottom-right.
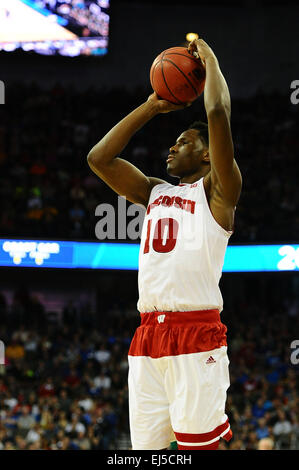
(137, 178), (232, 313)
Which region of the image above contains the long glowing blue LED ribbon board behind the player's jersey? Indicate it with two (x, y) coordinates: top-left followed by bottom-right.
(0, 238), (299, 273)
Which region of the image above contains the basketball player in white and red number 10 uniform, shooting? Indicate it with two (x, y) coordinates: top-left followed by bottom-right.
(88, 39), (241, 450)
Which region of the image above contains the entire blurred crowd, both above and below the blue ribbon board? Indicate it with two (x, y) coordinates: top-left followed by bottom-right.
(0, 83), (299, 450)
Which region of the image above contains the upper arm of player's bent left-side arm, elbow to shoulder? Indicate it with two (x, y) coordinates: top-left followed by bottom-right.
(88, 157), (165, 207)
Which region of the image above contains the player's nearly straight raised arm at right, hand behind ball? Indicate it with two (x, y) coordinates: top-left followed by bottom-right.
(188, 39), (242, 207)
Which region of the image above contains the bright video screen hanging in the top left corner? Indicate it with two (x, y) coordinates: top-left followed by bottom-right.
(0, 0), (110, 57)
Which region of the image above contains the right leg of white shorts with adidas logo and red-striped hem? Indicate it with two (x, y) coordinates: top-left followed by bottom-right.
(166, 346), (232, 450)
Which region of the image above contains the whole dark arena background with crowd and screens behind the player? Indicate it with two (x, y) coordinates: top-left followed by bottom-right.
(0, 0), (299, 451)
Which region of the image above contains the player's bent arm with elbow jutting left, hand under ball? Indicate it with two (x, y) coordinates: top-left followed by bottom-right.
(87, 93), (190, 207)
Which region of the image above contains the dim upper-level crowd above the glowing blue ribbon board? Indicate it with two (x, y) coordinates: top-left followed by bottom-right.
(0, 83), (299, 243)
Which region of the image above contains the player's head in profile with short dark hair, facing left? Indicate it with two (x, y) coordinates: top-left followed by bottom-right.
(167, 121), (210, 178)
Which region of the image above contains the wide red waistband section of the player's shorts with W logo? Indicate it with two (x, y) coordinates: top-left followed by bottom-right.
(128, 310), (227, 358)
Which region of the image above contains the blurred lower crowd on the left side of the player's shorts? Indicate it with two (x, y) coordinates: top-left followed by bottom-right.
(0, 293), (131, 450)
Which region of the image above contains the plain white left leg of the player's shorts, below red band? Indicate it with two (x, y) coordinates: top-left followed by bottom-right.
(128, 355), (172, 450)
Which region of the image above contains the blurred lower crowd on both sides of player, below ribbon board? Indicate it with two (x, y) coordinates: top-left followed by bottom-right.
(0, 284), (299, 450)
